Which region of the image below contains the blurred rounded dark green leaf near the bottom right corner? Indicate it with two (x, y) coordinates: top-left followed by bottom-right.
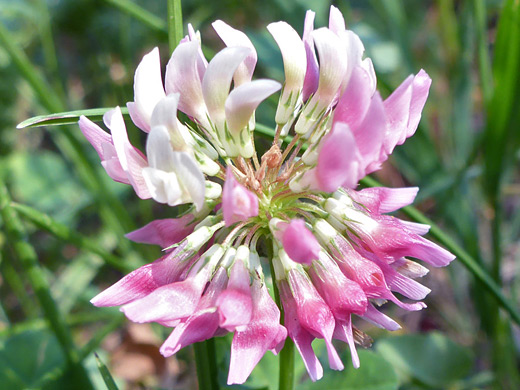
(376, 332), (473, 388)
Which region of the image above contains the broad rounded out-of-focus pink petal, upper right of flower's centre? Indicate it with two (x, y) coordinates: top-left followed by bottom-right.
(316, 122), (361, 192)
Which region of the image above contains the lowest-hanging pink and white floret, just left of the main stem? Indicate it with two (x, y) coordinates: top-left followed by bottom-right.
(227, 279), (287, 385)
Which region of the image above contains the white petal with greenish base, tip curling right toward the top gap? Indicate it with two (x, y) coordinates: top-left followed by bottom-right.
(226, 79), (282, 134)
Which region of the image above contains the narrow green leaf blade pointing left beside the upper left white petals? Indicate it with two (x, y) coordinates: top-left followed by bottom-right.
(16, 107), (128, 129)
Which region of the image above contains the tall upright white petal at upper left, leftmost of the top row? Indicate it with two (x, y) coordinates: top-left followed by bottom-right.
(134, 48), (165, 132)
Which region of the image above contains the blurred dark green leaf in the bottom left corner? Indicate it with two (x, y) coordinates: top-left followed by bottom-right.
(0, 330), (65, 390)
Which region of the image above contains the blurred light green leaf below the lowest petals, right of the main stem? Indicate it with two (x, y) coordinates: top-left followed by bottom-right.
(297, 350), (398, 390)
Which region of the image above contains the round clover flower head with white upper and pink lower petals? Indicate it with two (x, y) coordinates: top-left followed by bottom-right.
(79, 7), (454, 384)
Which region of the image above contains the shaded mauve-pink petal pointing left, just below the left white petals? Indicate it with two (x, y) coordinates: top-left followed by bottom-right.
(125, 214), (194, 248)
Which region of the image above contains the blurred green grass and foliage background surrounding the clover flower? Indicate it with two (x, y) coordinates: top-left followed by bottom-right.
(0, 0), (520, 390)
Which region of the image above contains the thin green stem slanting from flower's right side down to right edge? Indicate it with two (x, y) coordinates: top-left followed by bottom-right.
(361, 176), (520, 325)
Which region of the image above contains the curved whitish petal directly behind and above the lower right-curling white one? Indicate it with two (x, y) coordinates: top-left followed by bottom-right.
(202, 47), (251, 129)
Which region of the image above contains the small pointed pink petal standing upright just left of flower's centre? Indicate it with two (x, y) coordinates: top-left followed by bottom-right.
(222, 167), (258, 226)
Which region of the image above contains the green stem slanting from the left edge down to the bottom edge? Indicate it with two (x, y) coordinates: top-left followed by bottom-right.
(0, 182), (92, 389)
